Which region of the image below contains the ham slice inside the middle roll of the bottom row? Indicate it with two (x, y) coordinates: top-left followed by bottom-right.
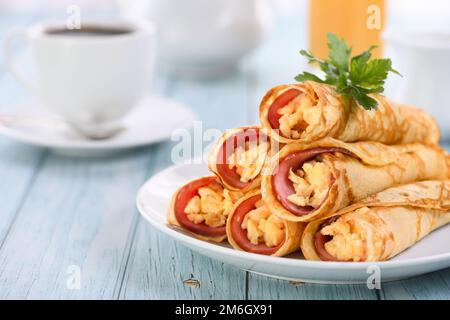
(230, 195), (284, 255)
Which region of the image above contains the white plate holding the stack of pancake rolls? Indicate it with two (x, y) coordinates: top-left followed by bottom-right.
(137, 164), (450, 283)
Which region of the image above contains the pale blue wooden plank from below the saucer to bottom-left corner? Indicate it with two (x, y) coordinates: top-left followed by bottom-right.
(0, 147), (156, 299)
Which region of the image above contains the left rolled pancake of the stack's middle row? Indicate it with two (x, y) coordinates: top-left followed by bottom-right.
(208, 126), (279, 192)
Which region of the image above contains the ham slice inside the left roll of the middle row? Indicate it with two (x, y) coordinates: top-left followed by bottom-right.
(216, 128), (269, 189)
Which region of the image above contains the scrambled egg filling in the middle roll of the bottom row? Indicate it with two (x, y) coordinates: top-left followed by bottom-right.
(241, 200), (285, 247)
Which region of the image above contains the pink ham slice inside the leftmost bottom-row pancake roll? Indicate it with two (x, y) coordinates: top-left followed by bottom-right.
(174, 177), (226, 238)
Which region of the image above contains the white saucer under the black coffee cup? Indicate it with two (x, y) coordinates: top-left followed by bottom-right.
(0, 96), (195, 156)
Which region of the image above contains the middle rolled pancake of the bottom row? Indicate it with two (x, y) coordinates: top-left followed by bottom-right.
(226, 191), (305, 257)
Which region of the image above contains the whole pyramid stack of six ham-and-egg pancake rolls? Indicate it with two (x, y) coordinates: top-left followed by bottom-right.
(168, 82), (450, 261)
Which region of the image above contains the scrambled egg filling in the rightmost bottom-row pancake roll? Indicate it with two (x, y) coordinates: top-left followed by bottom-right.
(320, 219), (365, 261)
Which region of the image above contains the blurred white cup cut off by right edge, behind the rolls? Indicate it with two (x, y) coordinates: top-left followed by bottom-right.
(383, 31), (450, 140)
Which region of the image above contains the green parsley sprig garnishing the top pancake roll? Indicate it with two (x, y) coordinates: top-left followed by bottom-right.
(295, 33), (401, 110)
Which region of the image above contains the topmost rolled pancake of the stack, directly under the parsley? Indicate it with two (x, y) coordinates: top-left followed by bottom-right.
(259, 81), (440, 145)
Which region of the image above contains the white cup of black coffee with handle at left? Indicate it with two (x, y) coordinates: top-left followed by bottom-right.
(4, 22), (155, 129)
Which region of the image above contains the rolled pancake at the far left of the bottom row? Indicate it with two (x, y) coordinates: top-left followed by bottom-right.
(167, 176), (243, 242)
